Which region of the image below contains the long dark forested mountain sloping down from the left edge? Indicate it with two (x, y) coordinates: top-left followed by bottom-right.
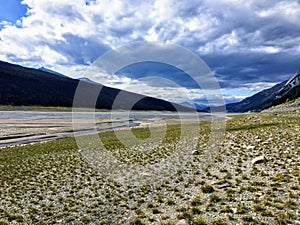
(0, 61), (191, 111)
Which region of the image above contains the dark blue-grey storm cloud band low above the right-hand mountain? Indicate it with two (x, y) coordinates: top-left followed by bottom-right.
(202, 53), (300, 88)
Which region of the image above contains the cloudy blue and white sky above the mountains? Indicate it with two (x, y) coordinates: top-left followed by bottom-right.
(0, 0), (300, 104)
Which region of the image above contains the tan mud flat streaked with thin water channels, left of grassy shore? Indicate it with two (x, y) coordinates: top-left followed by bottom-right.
(0, 118), (132, 147)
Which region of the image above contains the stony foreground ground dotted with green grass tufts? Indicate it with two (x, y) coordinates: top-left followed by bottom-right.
(0, 111), (300, 225)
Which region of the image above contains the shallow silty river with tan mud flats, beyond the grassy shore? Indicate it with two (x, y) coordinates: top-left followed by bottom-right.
(0, 111), (212, 147)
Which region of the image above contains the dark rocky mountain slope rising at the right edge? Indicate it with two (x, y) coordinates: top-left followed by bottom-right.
(226, 71), (300, 112)
